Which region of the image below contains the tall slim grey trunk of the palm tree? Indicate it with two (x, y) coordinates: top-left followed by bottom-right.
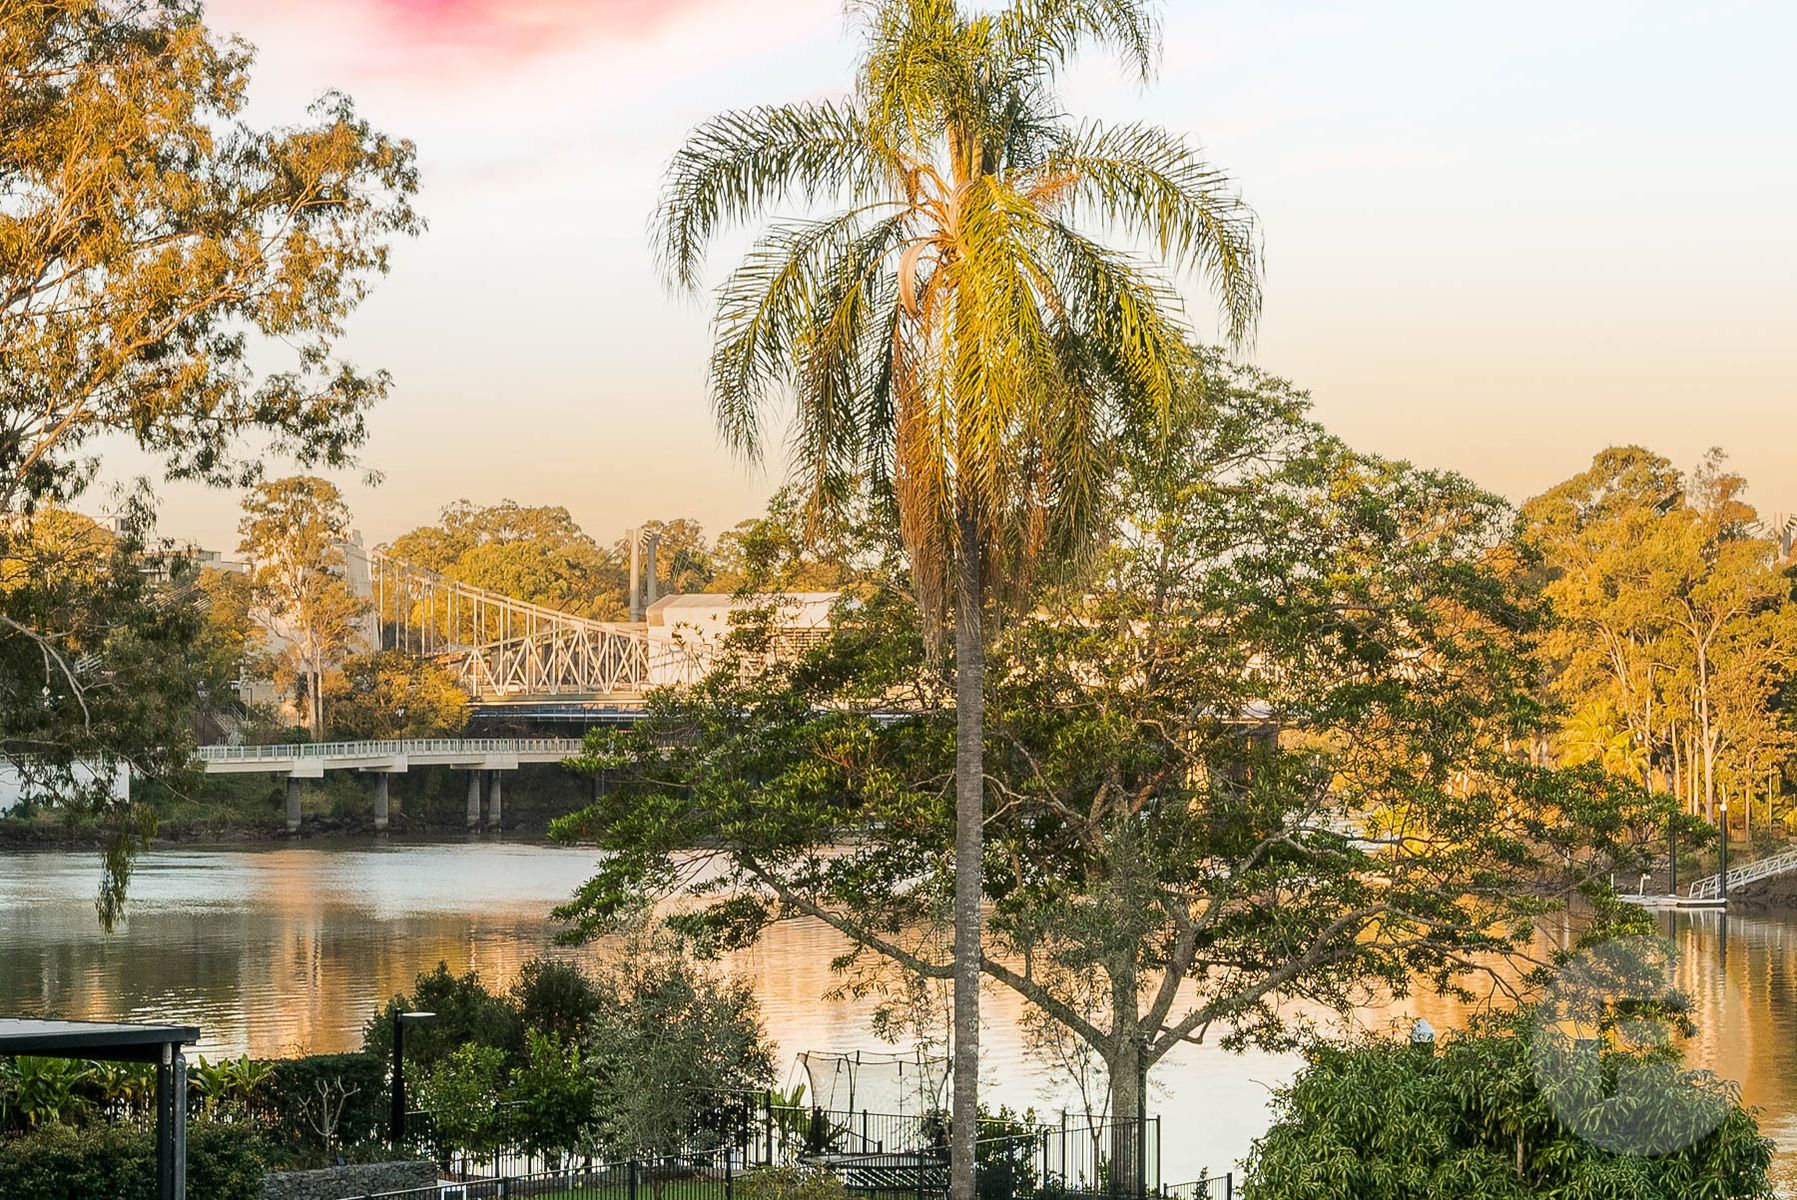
(949, 501), (987, 1200)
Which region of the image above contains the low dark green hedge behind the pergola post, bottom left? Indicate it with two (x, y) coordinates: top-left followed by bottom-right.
(0, 1121), (268, 1200)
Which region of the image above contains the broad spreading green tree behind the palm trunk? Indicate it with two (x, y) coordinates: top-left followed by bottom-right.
(559, 359), (1668, 1164)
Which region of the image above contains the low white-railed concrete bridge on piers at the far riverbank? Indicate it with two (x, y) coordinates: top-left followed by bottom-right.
(199, 738), (582, 832)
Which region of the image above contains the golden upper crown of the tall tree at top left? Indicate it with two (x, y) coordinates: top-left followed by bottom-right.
(0, 0), (420, 514)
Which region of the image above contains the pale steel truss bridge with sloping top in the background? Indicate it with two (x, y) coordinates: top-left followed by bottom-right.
(345, 546), (710, 708)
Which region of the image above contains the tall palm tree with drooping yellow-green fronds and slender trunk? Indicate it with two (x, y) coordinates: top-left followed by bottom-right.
(656, 0), (1260, 1200)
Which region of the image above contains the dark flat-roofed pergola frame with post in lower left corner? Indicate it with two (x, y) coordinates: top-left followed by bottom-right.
(0, 1017), (199, 1200)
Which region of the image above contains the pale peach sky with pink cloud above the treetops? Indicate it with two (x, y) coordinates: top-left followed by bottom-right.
(115, 0), (1797, 548)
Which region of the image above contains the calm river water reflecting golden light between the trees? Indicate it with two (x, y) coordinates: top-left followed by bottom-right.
(0, 841), (1797, 1195)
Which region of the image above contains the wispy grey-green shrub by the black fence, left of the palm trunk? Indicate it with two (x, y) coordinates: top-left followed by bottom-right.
(588, 940), (775, 1155)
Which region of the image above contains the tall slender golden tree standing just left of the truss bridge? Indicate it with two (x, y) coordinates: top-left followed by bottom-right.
(237, 474), (365, 740)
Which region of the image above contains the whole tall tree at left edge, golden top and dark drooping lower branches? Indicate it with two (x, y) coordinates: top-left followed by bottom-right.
(0, 0), (420, 913)
